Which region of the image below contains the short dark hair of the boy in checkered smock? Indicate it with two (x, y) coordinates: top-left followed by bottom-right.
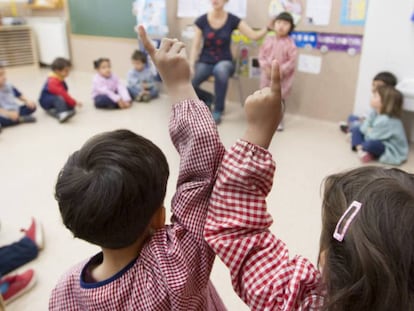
(55, 130), (169, 249)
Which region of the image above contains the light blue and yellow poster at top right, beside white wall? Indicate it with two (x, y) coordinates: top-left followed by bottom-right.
(341, 0), (368, 26)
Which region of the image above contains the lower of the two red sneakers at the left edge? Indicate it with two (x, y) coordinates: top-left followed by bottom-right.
(0, 269), (36, 305)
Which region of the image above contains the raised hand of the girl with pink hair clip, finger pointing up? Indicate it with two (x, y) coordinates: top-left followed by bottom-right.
(243, 61), (282, 148)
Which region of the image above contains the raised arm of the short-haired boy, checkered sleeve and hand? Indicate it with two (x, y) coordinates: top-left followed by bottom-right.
(139, 27), (224, 241)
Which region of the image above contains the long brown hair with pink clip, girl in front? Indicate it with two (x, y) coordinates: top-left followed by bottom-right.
(320, 166), (414, 311)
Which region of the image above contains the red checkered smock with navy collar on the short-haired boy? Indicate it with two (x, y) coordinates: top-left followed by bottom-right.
(49, 100), (230, 311)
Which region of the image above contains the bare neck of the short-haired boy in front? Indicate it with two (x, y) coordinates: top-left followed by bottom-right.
(92, 234), (148, 282)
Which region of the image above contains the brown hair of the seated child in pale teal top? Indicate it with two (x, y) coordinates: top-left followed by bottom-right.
(376, 85), (404, 118)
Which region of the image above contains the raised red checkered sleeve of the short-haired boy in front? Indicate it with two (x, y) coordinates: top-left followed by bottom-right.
(169, 100), (224, 242)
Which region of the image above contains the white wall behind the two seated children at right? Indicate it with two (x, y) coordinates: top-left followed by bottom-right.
(354, 0), (414, 139)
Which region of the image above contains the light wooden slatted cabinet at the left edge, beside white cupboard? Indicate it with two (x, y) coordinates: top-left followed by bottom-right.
(0, 26), (37, 67)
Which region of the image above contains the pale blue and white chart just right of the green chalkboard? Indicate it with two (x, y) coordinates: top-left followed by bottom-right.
(133, 0), (168, 37)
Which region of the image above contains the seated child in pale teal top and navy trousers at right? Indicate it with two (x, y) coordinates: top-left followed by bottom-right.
(351, 86), (409, 165)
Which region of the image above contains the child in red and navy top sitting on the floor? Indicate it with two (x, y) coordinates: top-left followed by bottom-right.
(39, 57), (81, 123)
